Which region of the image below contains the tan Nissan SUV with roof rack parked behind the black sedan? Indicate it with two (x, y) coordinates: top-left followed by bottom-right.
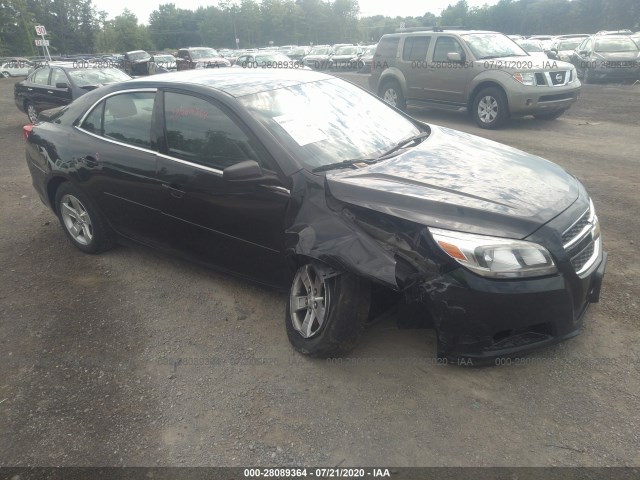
(369, 29), (580, 128)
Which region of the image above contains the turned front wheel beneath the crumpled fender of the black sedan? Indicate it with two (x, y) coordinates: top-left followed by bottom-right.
(285, 262), (371, 358)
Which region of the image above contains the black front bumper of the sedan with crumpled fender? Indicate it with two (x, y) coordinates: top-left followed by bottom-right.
(421, 249), (607, 364)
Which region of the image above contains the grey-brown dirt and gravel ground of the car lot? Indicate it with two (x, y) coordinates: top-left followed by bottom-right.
(0, 74), (640, 466)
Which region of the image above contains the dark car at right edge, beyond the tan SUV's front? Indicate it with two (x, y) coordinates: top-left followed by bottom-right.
(571, 35), (640, 83)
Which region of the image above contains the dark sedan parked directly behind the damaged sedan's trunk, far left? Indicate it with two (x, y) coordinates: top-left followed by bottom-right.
(13, 62), (131, 123)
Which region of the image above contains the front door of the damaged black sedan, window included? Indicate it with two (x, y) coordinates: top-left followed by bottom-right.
(158, 91), (289, 284)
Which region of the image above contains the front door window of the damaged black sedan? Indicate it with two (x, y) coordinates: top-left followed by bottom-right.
(164, 92), (260, 170)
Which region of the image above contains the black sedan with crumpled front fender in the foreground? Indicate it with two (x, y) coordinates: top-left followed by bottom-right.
(24, 69), (607, 360)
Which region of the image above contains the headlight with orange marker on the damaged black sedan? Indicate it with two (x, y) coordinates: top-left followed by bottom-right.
(429, 227), (558, 278)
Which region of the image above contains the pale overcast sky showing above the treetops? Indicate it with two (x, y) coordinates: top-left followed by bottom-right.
(93, 0), (497, 23)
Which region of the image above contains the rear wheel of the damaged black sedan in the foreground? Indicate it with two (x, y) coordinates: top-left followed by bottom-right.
(55, 182), (114, 253)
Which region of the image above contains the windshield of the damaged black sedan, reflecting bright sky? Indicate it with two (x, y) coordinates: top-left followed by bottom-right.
(240, 79), (420, 169)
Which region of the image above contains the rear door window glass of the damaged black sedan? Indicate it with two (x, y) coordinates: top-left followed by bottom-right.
(103, 92), (156, 148)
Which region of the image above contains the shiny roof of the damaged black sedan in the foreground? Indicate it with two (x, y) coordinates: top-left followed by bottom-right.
(127, 67), (335, 97)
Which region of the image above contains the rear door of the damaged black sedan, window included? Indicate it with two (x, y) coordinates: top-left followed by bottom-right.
(74, 89), (166, 245)
